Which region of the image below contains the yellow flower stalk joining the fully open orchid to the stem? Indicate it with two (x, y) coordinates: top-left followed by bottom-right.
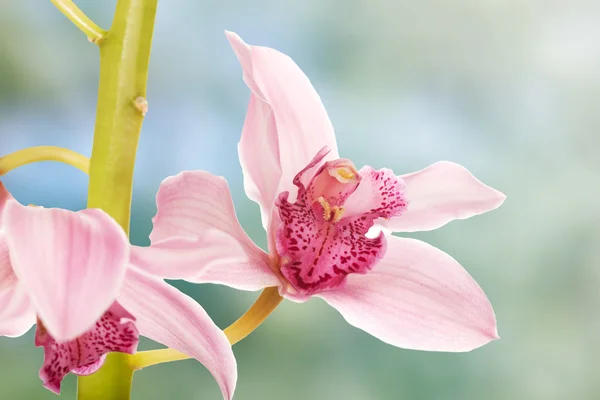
(131, 287), (283, 370)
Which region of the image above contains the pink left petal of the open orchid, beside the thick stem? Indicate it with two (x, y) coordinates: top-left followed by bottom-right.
(136, 171), (279, 290)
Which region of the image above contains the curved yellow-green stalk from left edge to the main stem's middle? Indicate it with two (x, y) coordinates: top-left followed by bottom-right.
(0, 146), (90, 175)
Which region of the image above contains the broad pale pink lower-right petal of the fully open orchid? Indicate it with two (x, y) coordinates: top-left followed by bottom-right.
(317, 236), (498, 352)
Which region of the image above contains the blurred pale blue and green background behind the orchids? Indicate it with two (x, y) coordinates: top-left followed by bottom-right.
(0, 0), (600, 400)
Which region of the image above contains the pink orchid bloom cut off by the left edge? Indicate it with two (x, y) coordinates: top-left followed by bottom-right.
(0, 183), (237, 399)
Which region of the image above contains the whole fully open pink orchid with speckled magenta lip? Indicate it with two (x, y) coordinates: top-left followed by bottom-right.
(132, 32), (505, 351)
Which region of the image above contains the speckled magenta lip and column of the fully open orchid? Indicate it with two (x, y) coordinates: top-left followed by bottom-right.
(275, 148), (406, 295)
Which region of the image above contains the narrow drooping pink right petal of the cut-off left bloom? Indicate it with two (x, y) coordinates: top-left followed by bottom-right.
(119, 267), (237, 399)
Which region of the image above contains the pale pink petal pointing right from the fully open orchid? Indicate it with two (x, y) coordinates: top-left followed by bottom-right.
(381, 161), (506, 232)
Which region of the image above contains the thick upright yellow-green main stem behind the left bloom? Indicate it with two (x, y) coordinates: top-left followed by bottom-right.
(78, 0), (158, 400)
